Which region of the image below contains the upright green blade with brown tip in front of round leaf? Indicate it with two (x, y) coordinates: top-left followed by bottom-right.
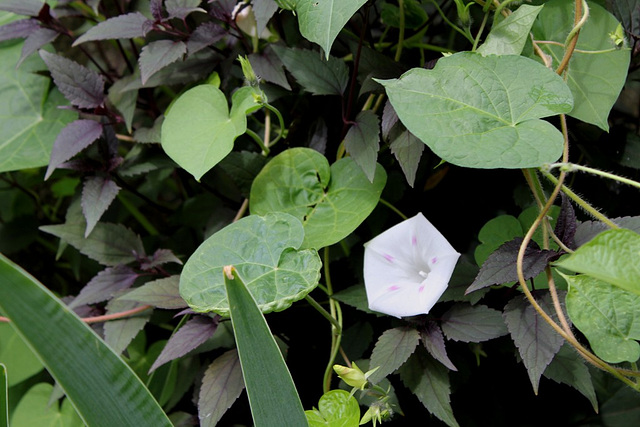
(223, 266), (307, 427)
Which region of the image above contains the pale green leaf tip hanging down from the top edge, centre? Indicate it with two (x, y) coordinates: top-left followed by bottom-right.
(295, 0), (367, 58)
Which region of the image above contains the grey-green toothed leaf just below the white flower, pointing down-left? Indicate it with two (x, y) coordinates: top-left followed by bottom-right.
(369, 327), (420, 384)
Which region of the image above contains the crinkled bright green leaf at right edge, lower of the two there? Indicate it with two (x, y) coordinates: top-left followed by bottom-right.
(563, 274), (640, 363)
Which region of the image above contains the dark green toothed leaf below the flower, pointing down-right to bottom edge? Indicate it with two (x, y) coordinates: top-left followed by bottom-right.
(400, 349), (458, 427)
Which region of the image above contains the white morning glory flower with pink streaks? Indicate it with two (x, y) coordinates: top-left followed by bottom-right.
(364, 213), (460, 317)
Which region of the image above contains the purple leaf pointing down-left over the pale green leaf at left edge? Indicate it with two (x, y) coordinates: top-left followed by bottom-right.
(44, 120), (102, 179)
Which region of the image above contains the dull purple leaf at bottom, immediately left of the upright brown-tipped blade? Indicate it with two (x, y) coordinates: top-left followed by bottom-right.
(198, 349), (244, 426)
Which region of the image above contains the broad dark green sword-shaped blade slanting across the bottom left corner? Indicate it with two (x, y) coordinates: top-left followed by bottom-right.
(0, 254), (171, 426)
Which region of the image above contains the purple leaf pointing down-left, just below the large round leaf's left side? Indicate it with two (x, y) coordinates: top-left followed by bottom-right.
(149, 316), (220, 373)
